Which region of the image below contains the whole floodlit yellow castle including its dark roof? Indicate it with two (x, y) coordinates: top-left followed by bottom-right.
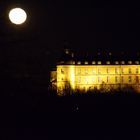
(51, 50), (140, 94)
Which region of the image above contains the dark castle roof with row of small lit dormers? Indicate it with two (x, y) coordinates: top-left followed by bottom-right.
(57, 50), (140, 65)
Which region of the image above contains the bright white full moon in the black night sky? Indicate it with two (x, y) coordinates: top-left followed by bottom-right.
(9, 8), (27, 25)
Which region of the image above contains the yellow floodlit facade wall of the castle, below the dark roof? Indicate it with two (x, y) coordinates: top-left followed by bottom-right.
(57, 65), (140, 93)
